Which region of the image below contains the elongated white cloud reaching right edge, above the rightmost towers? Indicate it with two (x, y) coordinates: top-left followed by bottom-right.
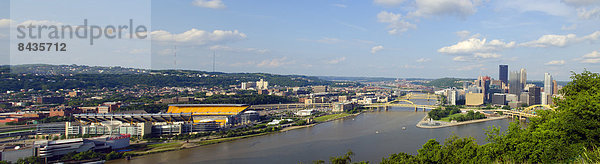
(519, 31), (600, 47)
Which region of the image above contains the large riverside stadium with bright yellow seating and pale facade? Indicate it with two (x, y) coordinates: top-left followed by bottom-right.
(65, 104), (259, 136)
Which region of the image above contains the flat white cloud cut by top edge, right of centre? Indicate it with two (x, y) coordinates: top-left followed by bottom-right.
(409, 0), (481, 18)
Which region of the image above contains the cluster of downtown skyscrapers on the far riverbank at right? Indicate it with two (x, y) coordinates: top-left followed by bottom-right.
(437, 65), (561, 108)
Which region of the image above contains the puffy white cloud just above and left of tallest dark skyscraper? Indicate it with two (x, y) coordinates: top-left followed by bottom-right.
(438, 38), (516, 54)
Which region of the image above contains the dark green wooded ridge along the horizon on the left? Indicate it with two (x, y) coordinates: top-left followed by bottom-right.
(0, 66), (358, 92)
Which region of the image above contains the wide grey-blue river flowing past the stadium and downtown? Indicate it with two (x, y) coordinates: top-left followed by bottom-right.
(108, 99), (510, 164)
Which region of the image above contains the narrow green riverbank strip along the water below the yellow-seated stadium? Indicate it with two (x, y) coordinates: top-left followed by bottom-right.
(119, 113), (361, 158)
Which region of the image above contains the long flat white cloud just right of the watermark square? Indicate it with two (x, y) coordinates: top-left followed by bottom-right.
(150, 29), (246, 45)
